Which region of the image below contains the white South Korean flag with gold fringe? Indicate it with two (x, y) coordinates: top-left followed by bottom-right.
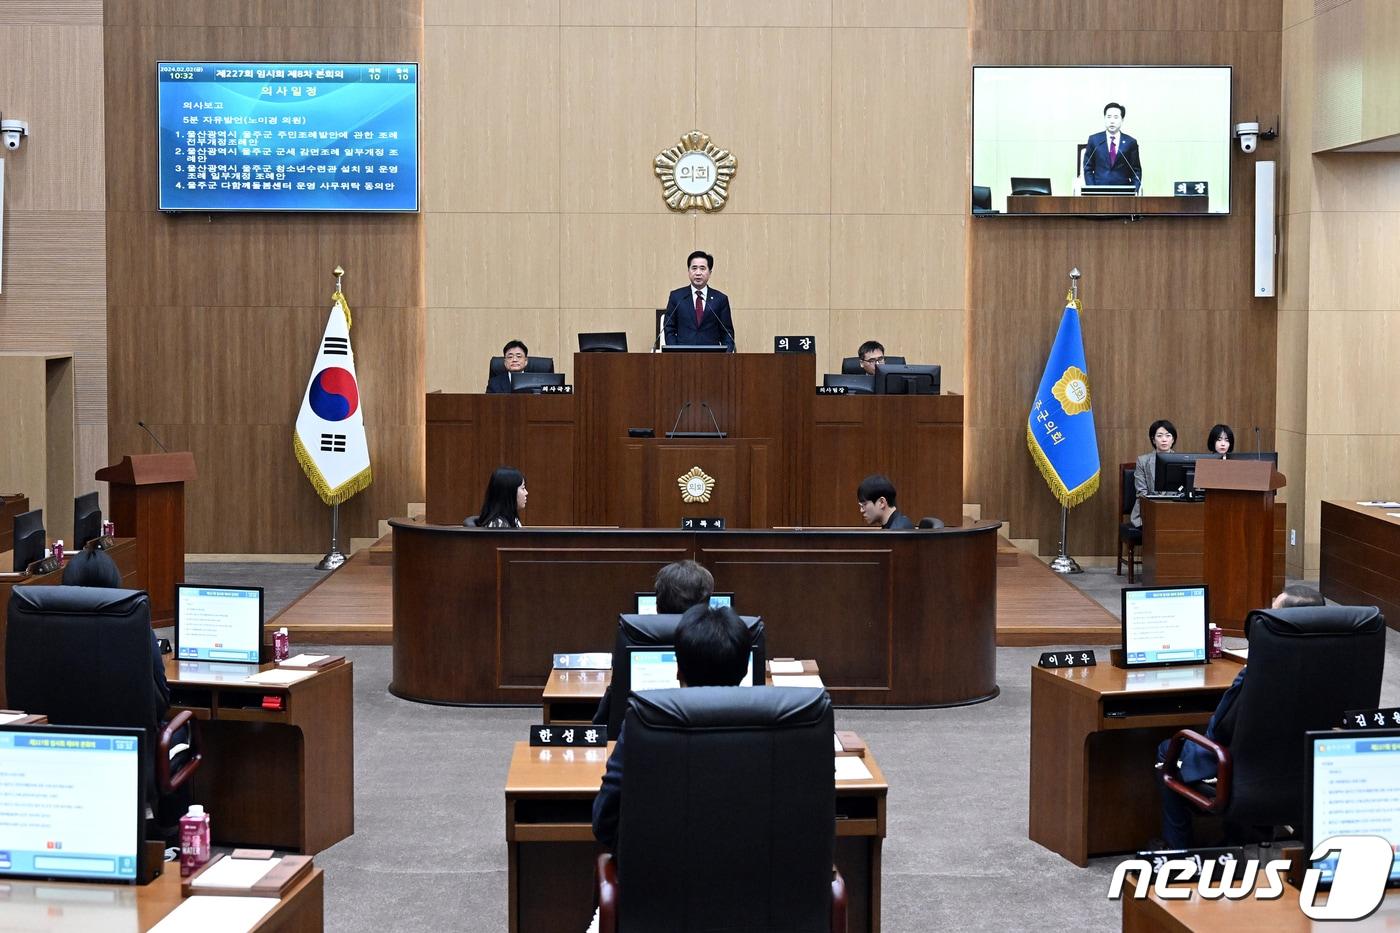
(293, 290), (372, 506)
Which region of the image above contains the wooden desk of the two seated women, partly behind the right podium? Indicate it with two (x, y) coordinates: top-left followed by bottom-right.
(1142, 499), (1288, 636)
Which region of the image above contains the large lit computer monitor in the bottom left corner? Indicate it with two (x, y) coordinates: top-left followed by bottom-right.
(0, 726), (147, 883)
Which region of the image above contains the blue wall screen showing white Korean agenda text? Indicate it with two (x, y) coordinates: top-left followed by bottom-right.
(157, 62), (419, 212)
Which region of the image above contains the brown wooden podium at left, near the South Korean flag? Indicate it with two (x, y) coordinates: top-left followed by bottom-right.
(95, 451), (197, 628)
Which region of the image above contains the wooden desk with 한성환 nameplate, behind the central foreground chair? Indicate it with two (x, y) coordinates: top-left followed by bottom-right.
(505, 742), (889, 933)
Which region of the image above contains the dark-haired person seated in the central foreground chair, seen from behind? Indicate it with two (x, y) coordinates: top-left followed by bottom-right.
(594, 605), (752, 849)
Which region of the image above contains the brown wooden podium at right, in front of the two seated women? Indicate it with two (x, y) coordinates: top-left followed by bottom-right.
(1196, 459), (1287, 635)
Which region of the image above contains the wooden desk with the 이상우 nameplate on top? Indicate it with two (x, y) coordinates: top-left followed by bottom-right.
(1030, 658), (1240, 867)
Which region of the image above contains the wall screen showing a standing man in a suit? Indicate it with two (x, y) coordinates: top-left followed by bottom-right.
(972, 66), (1233, 216)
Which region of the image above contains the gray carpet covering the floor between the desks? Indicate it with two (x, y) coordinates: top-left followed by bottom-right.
(200, 565), (1400, 933)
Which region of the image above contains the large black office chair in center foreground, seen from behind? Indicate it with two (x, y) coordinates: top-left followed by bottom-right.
(596, 686), (846, 933)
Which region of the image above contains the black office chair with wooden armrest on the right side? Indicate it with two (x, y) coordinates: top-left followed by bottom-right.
(1162, 605), (1386, 838)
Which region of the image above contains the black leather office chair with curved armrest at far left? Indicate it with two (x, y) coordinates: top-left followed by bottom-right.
(4, 586), (203, 832)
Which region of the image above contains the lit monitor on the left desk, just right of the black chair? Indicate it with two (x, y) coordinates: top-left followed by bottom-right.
(175, 583), (263, 664)
